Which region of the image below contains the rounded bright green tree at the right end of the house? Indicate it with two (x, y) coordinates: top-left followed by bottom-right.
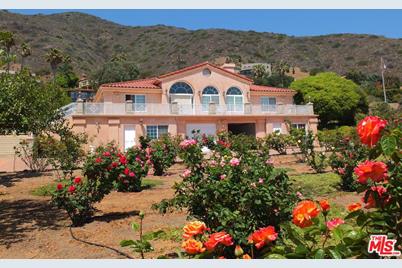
(290, 73), (362, 127)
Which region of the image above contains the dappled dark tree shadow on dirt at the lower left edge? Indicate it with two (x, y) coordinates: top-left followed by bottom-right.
(0, 199), (66, 247)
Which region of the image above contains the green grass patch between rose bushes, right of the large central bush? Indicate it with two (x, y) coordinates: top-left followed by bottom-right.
(290, 172), (340, 198)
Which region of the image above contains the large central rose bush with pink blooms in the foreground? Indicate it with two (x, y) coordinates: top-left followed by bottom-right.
(155, 140), (296, 257)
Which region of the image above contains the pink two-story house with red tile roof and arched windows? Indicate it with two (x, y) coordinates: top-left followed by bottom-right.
(65, 62), (318, 152)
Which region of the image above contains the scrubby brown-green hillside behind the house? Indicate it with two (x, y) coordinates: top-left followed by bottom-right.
(0, 11), (402, 78)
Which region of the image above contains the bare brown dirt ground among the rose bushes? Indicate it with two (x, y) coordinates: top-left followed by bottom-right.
(0, 158), (357, 259)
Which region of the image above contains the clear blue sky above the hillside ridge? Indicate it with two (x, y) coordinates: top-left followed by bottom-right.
(11, 9), (402, 38)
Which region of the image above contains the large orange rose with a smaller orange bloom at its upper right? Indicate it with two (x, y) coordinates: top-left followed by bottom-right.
(293, 200), (320, 228)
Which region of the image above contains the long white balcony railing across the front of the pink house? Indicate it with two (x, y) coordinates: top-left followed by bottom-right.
(63, 102), (314, 116)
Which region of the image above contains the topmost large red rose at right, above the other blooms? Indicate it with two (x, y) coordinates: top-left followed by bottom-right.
(357, 116), (387, 148)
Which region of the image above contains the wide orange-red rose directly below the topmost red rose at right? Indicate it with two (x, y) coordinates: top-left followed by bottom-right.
(354, 160), (388, 184)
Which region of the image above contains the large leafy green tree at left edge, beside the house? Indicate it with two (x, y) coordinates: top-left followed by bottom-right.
(0, 69), (69, 135)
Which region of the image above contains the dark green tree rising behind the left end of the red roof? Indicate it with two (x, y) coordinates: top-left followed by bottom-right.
(92, 60), (140, 87)
